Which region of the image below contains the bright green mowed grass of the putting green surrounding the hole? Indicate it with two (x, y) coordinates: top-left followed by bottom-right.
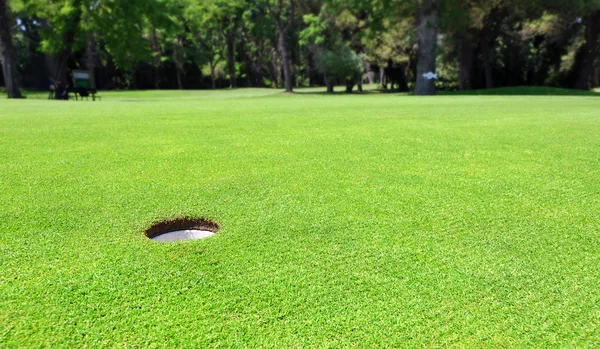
(0, 90), (600, 348)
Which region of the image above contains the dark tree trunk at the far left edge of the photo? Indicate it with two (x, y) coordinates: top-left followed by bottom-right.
(0, 0), (23, 98)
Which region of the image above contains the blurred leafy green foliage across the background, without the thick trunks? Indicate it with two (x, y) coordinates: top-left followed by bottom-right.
(3, 0), (600, 89)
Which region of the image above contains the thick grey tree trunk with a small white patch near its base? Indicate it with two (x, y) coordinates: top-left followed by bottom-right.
(415, 0), (440, 96)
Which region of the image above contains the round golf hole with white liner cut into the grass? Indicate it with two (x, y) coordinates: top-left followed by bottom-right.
(145, 217), (219, 242)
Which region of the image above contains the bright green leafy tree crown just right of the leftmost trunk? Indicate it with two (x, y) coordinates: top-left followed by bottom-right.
(15, 0), (164, 93)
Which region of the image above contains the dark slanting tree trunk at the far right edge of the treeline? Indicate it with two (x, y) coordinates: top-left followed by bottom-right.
(574, 11), (600, 90)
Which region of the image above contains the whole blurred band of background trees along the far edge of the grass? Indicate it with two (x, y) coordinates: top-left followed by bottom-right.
(0, 0), (600, 94)
